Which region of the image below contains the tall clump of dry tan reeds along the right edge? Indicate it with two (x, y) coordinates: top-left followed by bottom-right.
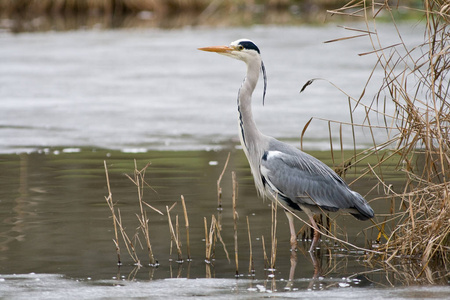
(331, 0), (450, 277)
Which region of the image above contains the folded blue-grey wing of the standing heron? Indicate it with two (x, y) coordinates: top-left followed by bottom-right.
(261, 148), (370, 214)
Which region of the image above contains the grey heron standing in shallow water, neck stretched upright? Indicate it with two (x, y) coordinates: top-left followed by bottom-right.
(199, 39), (374, 252)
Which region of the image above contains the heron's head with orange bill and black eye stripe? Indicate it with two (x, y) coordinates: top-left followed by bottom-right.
(198, 39), (261, 63)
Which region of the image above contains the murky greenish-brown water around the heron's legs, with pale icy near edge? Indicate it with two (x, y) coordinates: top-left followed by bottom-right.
(0, 148), (445, 299)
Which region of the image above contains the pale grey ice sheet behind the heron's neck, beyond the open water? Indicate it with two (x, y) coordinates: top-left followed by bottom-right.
(0, 24), (422, 152)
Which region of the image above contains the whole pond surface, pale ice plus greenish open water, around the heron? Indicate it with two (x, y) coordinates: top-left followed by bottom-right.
(0, 25), (450, 299)
